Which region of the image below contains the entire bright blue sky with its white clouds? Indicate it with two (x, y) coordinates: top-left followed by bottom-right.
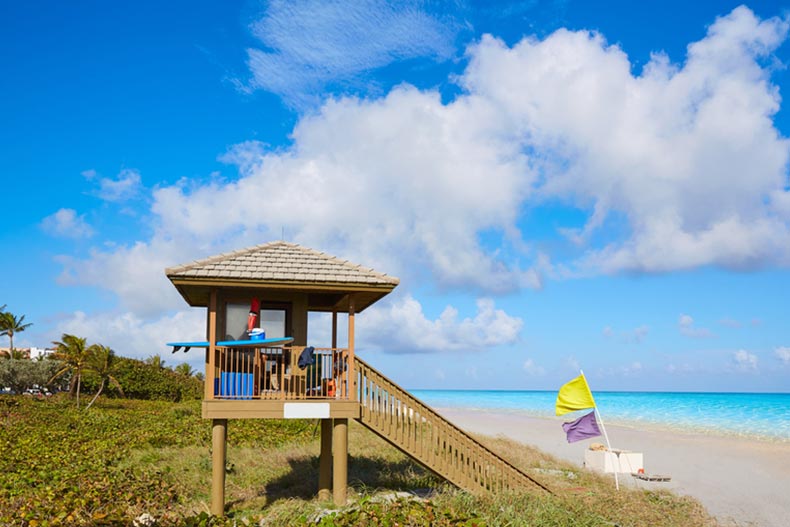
(0, 0), (790, 392)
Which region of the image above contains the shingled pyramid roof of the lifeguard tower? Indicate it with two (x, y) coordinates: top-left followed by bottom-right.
(165, 241), (399, 310)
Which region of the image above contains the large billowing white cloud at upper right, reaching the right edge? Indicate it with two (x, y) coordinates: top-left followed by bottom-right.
(463, 7), (790, 273)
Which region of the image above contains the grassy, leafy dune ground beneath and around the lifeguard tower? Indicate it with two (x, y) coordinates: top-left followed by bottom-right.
(0, 396), (715, 527)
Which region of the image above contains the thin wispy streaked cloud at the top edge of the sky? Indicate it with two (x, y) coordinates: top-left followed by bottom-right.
(247, 0), (455, 107)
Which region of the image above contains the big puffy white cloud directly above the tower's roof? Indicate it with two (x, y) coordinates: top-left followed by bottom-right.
(153, 87), (541, 292)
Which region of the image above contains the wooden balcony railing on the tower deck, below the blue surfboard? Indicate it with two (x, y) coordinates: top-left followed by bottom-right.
(207, 346), (349, 400)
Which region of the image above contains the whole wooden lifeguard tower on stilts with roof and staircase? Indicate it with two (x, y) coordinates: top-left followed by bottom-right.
(165, 242), (545, 515)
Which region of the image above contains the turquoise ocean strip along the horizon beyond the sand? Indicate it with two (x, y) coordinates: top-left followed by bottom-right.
(410, 390), (790, 442)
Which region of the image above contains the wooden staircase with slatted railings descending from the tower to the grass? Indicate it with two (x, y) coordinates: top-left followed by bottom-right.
(356, 357), (551, 493)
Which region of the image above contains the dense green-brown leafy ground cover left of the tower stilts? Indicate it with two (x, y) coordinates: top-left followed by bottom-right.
(0, 396), (312, 527)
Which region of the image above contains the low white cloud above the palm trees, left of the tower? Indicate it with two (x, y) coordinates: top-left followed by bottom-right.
(54, 309), (206, 371)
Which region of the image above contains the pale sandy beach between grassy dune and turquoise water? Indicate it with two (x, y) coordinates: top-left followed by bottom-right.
(440, 409), (790, 527)
